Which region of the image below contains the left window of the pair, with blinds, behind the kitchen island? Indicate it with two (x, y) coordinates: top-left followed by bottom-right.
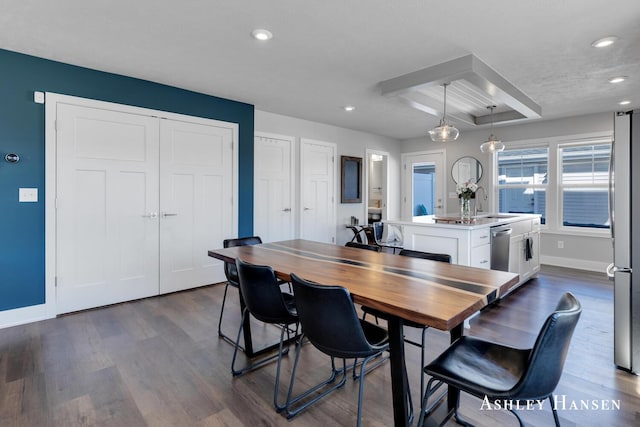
(497, 147), (549, 224)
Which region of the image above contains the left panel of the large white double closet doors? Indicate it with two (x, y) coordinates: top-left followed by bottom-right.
(56, 104), (158, 313)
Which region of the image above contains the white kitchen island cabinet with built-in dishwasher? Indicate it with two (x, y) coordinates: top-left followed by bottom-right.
(387, 214), (540, 289)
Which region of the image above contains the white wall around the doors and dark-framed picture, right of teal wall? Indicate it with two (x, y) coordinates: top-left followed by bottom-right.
(254, 110), (401, 245)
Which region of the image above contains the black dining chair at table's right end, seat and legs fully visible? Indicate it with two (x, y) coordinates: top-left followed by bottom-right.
(418, 292), (582, 427)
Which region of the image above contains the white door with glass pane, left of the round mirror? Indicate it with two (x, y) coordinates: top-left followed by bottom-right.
(403, 152), (446, 217)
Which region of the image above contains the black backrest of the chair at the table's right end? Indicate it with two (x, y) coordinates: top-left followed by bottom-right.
(512, 292), (582, 399)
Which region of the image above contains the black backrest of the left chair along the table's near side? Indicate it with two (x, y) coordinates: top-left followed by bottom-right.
(236, 259), (291, 323)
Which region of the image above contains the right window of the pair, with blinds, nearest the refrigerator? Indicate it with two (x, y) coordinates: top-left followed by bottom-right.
(558, 143), (611, 228)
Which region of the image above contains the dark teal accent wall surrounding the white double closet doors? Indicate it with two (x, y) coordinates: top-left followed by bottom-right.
(0, 49), (254, 311)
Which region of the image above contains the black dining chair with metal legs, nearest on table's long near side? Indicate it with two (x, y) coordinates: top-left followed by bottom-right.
(286, 273), (389, 426)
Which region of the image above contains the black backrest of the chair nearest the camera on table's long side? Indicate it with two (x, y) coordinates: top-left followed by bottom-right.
(291, 273), (372, 358)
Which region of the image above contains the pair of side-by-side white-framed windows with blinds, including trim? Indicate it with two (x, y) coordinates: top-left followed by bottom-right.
(494, 133), (613, 232)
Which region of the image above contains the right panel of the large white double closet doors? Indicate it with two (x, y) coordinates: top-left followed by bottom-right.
(159, 119), (234, 293)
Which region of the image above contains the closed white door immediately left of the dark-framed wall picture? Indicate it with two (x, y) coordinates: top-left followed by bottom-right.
(300, 139), (337, 243)
